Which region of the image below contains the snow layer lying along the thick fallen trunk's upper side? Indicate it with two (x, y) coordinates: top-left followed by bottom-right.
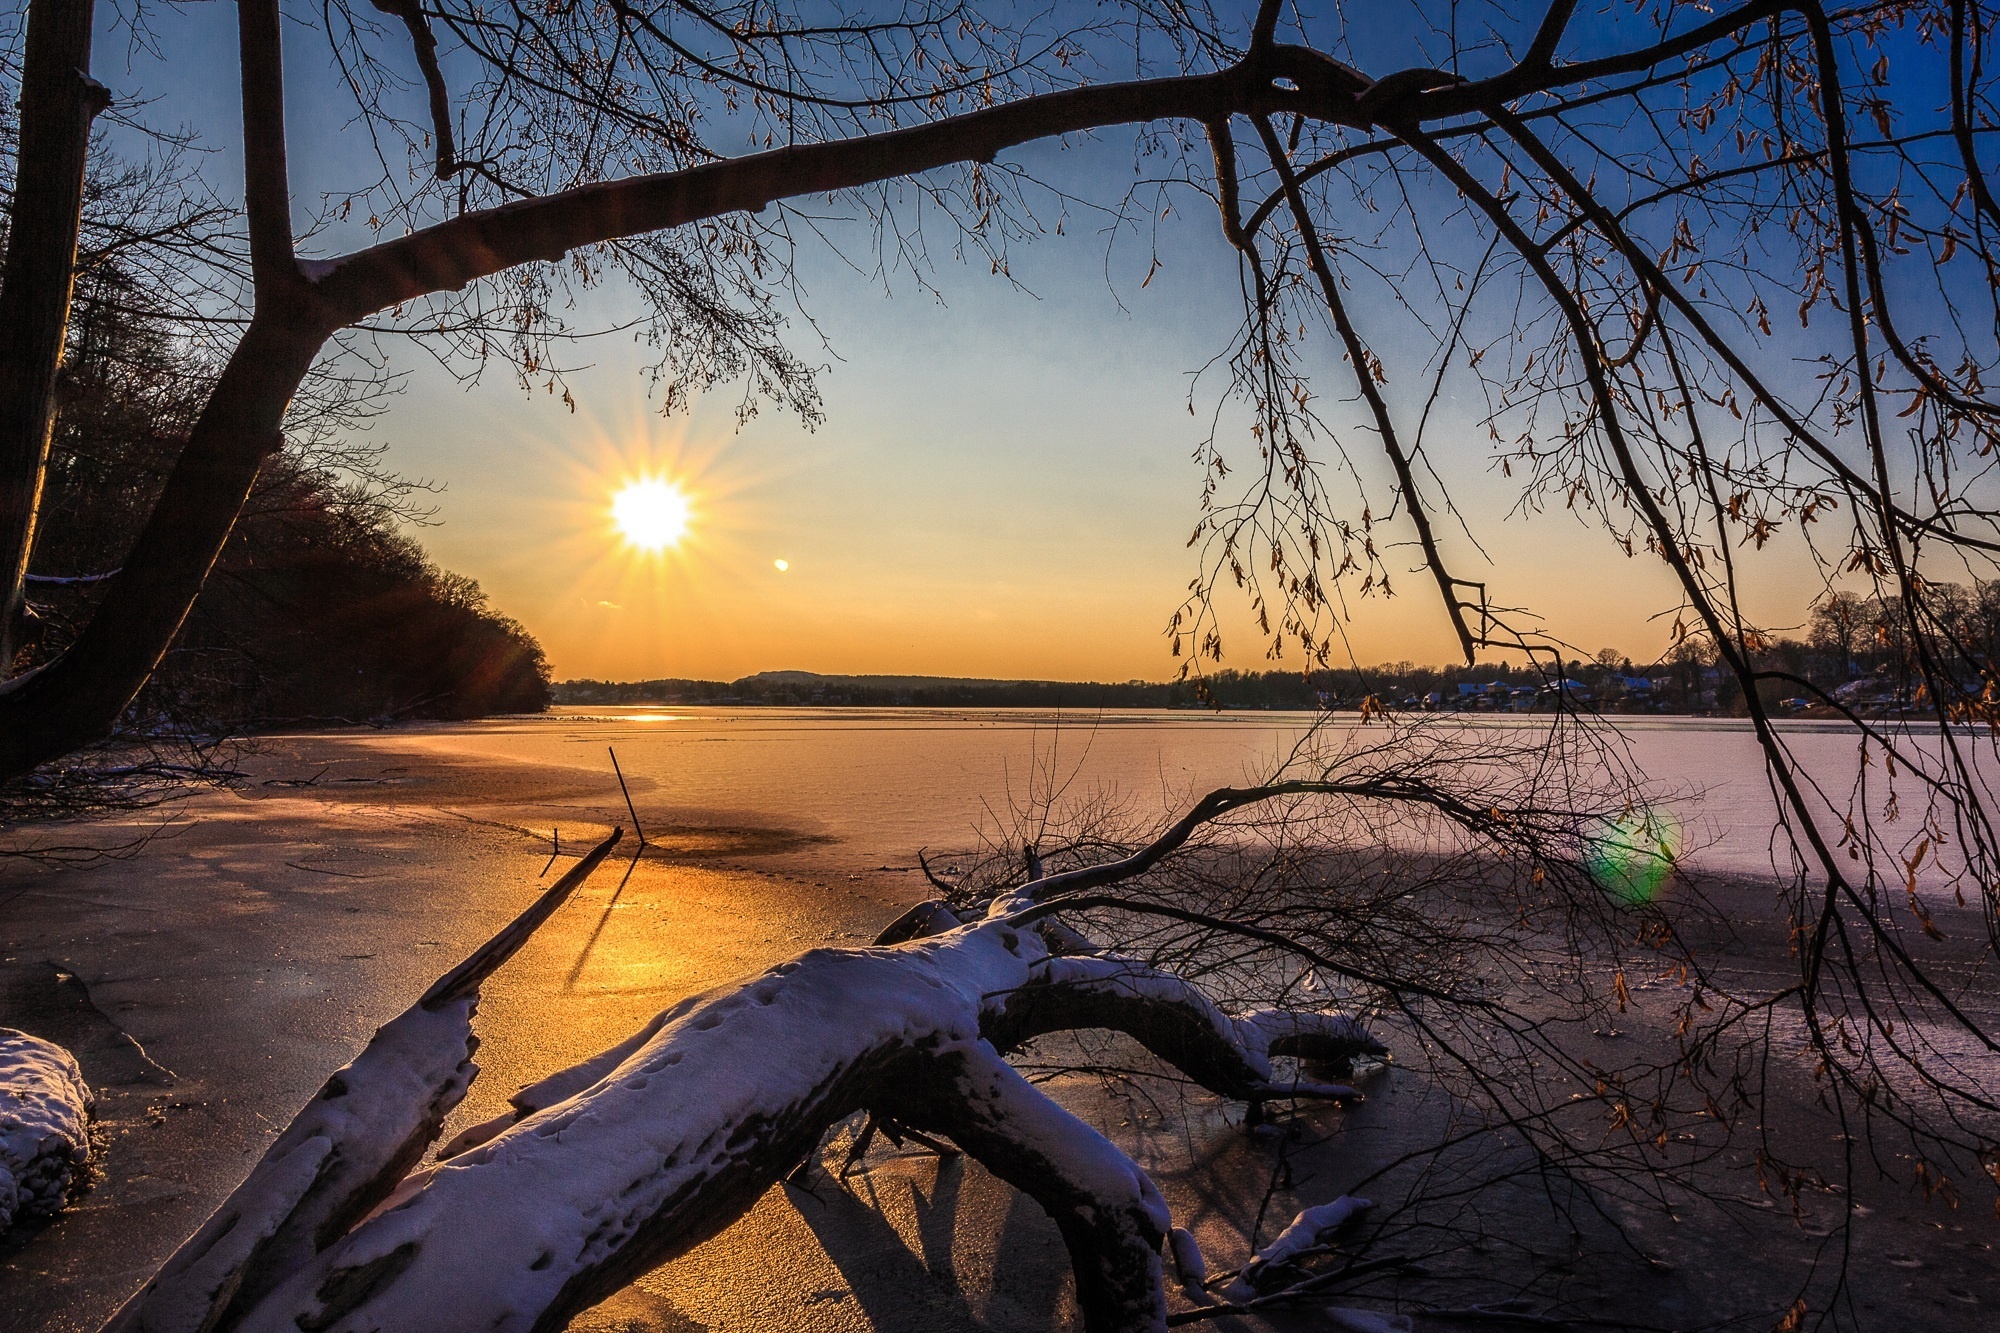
(240, 925), (1056, 1333)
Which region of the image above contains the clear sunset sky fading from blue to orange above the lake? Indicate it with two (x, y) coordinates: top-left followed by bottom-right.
(70, 4), (1810, 681)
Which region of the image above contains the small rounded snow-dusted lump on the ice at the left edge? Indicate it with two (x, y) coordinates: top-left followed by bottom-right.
(0, 1027), (94, 1231)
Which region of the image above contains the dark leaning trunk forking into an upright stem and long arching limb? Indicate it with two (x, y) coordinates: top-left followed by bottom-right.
(0, 31), (1368, 781)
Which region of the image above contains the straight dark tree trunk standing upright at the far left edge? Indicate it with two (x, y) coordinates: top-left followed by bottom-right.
(0, 0), (110, 679)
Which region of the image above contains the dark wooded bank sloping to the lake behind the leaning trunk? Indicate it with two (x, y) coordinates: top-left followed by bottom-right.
(16, 240), (550, 733)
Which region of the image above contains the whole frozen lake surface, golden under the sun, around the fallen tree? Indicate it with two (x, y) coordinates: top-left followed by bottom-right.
(0, 709), (2000, 1333)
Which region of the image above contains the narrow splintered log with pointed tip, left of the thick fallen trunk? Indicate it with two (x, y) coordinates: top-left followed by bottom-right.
(106, 829), (618, 1333)
